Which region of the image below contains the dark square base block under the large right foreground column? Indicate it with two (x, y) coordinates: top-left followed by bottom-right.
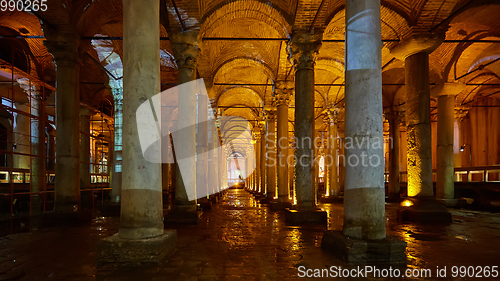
(321, 230), (406, 264)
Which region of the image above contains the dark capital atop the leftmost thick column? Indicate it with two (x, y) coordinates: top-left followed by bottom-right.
(43, 30), (81, 65)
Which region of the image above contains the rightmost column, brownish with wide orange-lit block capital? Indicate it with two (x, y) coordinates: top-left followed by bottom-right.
(431, 83), (465, 206)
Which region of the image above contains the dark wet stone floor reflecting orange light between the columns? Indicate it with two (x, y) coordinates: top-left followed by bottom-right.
(0, 189), (500, 281)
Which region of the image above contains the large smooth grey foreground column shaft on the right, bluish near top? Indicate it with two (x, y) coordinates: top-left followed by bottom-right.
(343, 0), (386, 240)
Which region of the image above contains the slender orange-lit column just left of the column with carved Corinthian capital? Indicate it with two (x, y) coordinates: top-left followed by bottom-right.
(275, 82), (293, 203)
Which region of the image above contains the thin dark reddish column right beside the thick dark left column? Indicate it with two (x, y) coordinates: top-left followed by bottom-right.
(80, 106), (93, 206)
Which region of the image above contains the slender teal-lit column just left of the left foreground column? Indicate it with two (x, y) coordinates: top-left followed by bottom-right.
(111, 88), (123, 203)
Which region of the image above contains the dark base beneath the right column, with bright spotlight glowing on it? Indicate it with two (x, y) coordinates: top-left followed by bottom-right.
(398, 197), (452, 224)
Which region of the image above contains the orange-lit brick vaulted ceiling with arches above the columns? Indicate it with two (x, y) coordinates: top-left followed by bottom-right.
(0, 0), (500, 136)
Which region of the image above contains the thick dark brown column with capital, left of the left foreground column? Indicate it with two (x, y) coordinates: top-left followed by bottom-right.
(44, 31), (80, 214)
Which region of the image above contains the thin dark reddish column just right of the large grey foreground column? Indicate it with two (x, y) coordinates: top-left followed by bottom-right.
(385, 107), (401, 199)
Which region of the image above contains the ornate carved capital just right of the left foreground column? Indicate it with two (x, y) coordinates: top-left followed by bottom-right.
(169, 30), (201, 69)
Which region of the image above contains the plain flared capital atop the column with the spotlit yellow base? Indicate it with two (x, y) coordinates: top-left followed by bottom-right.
(391, 32), (444, 60)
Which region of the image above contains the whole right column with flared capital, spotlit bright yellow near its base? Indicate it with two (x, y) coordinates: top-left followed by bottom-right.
(391, 33), (451, 223)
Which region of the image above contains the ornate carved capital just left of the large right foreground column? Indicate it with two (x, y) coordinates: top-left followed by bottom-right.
(289, 32), (323, 69)
